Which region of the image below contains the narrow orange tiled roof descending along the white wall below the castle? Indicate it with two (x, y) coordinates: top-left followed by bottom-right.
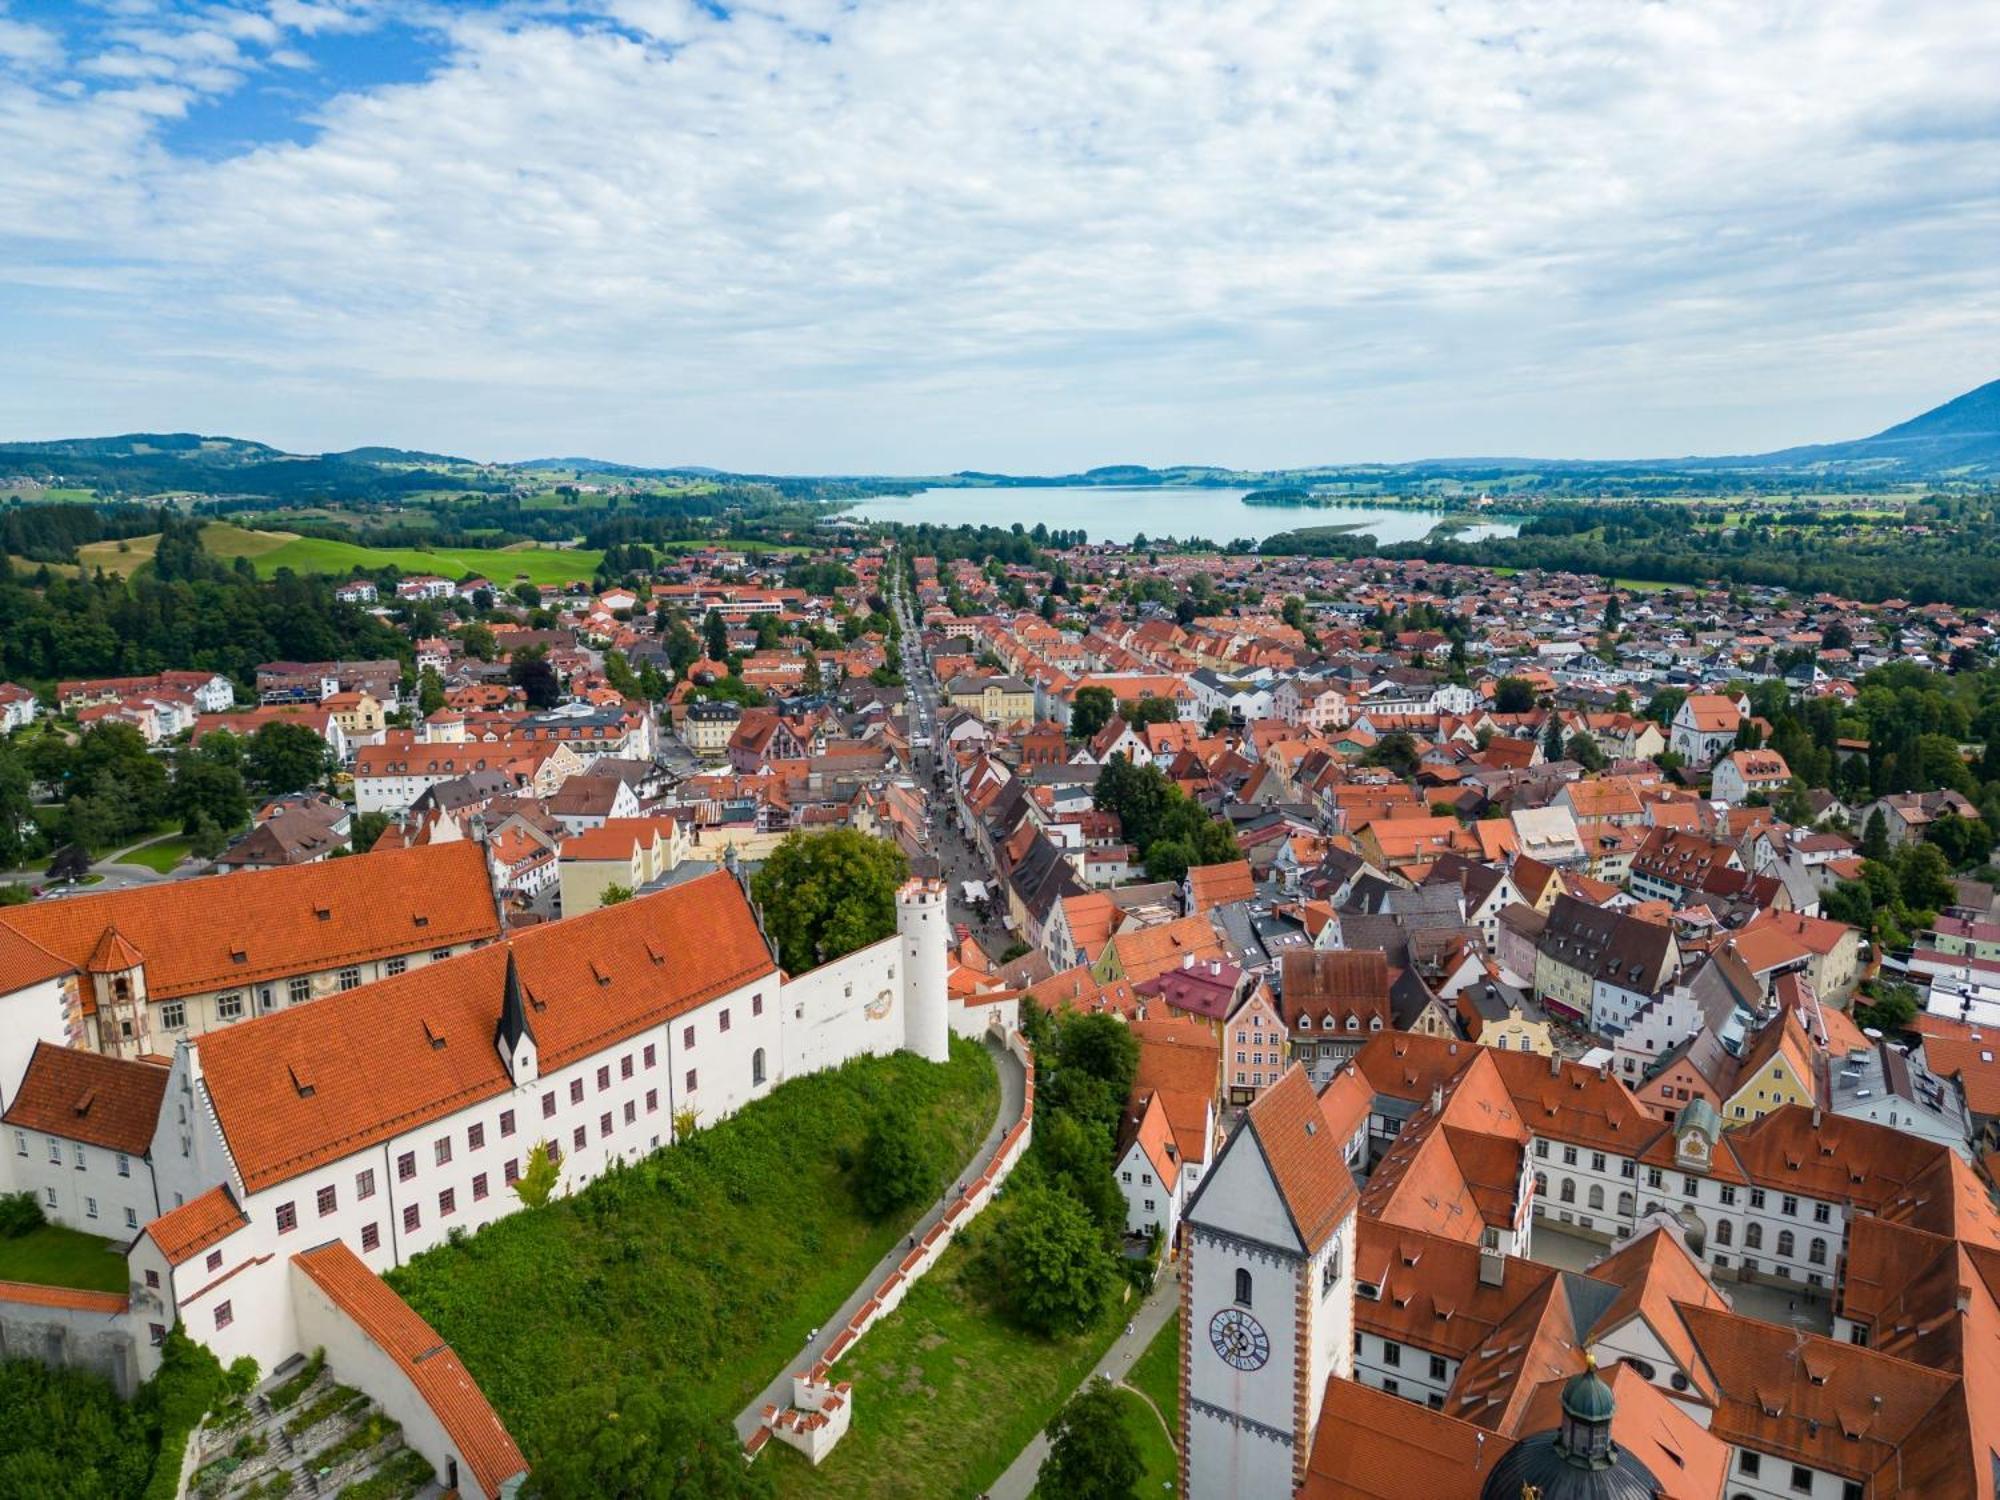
(292, 1240), (528, 1494)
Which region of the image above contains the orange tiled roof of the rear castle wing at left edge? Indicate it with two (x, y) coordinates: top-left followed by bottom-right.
(0, 842), (500, 1010)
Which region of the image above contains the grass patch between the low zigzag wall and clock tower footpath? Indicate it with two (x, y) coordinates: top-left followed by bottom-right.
(758, 1194), (1136, 1500)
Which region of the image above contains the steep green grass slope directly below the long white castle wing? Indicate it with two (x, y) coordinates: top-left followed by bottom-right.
(388, 1040), (1000, 1462)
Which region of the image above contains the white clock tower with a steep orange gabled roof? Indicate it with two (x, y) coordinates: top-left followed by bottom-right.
(1180, 1066), (1360, 1500)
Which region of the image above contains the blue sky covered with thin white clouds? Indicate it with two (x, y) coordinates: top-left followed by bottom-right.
(0, 0), (2000, 474)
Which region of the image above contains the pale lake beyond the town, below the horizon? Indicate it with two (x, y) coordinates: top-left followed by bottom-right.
(844, 484), (1520, 544)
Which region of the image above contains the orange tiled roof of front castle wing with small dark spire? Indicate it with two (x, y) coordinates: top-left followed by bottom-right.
(192, 876), (776, 1192)
